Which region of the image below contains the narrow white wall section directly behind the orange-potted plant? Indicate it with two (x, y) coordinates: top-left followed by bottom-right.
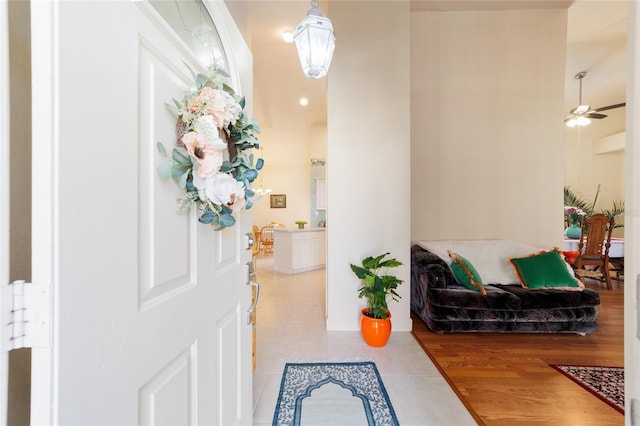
(327, 1), (411, 331)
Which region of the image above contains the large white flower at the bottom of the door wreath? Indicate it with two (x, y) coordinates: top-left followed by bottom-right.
(193, 173), (246, 213)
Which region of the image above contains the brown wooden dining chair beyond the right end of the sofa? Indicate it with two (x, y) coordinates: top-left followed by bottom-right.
(575, 213), (613, 290)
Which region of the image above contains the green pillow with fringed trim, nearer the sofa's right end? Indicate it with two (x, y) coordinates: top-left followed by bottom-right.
(509, 249), (581, 289)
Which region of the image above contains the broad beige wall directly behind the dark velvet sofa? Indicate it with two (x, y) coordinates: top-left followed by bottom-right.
(411, 9), (567, 247)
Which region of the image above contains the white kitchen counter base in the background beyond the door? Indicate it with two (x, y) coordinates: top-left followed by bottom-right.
(273, 228), (326, 274)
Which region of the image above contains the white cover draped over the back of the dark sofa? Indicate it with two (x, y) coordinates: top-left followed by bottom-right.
(417, 240), (544, 284)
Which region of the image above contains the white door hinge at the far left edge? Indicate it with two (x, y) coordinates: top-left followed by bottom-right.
(1, 280), (50, 351)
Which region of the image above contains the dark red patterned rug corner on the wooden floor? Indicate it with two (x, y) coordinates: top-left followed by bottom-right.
(551, 364), (624, 414)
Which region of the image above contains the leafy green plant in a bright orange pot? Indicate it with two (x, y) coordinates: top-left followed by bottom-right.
(351, 253), (403, 347)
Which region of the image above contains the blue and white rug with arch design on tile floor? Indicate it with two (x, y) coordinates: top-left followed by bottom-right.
(273, 362), (399, 426)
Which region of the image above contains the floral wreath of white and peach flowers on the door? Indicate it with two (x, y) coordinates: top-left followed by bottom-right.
(157, 66), (264, 230)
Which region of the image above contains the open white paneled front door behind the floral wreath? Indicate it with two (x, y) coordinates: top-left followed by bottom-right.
(31, 1), (252, 425)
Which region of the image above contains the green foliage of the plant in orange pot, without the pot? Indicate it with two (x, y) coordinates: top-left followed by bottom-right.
(351, 253), (404, 319)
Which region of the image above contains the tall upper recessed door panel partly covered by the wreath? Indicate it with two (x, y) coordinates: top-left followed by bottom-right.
(138, 33), (196, 306)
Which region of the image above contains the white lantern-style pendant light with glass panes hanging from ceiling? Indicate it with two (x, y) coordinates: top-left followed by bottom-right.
(293, 0), (335, 78)
